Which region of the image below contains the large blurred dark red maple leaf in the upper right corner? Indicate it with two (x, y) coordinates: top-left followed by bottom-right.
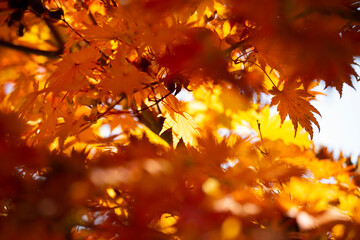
(236, 0), (358, 96)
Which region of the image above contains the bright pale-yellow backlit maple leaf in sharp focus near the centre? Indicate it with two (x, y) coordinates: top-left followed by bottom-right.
(160, 112), (200, 148)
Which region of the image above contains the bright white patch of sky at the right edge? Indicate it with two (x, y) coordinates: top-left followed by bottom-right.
(312, 78), (360, 162)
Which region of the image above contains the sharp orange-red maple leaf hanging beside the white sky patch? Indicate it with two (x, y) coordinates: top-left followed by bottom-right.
(269, 81), (321, 139)
